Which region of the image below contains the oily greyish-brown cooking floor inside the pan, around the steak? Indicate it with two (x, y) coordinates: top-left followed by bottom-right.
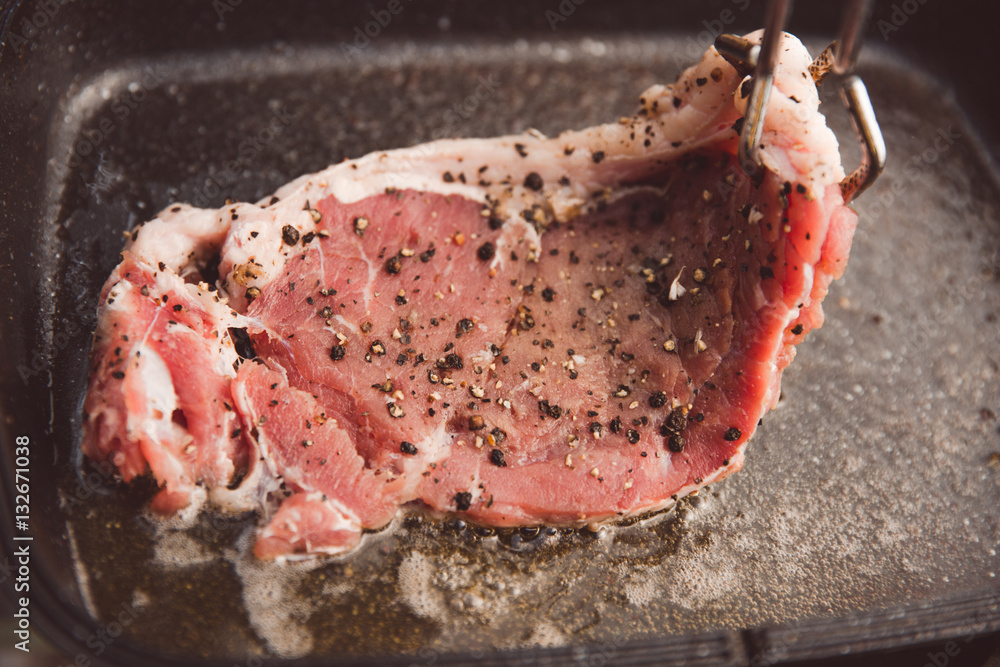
(0, 2), (1000, 664)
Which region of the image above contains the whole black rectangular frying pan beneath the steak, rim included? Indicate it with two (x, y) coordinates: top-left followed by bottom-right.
(0, 0), (1000, 665)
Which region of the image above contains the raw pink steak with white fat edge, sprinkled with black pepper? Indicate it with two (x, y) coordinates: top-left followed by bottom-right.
(82, 34), (856, 558)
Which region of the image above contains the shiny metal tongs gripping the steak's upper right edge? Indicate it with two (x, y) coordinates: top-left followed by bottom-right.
(715, 0), (886, 203)
